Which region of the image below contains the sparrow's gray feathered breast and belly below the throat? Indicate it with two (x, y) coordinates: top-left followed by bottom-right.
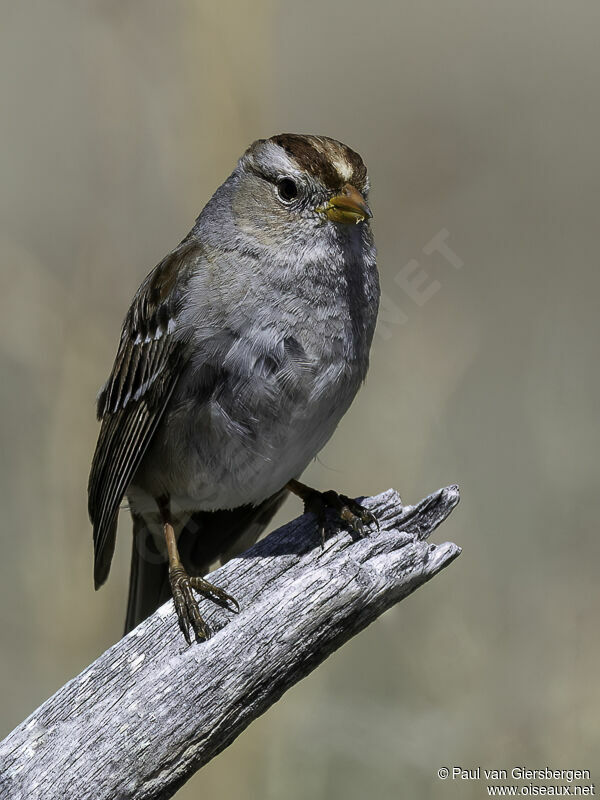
(135, 223), (379, 509)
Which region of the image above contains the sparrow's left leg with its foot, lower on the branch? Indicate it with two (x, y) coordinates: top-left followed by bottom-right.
(156, 497), (240, 644)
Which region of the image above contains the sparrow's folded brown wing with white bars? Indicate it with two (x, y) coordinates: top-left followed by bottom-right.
(88, 241), (194, 588)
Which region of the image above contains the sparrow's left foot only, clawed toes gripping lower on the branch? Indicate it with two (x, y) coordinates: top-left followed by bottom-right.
(169, 566), (240, 644)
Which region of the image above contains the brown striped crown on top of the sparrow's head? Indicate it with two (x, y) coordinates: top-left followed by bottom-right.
(271, 133), (367, 191)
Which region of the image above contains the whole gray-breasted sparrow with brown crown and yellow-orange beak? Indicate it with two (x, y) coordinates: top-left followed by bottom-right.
(88, 133), (380, 644)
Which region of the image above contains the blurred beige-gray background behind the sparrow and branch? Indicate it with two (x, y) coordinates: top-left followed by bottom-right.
(0, 0), (600, 800)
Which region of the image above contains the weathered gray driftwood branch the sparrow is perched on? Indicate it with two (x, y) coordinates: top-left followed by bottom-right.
(0, 486), (460, 800)
